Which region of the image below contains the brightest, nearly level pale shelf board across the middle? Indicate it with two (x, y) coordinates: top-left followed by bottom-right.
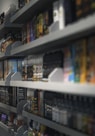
(10, 81), (95, 97)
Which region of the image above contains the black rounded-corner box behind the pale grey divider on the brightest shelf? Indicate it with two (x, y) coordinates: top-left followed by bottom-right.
(43, 50), (63, 78)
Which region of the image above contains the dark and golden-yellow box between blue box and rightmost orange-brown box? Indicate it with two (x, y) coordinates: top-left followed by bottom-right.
(73, 39), (87, 83)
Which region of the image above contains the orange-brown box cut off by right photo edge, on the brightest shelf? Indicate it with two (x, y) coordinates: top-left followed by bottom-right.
(87, 36), (95, 83)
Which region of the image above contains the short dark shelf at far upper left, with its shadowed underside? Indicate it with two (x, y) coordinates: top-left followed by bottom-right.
(0, 22), (22, 38)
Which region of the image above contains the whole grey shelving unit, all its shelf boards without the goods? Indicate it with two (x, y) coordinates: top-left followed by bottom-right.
(0, 0), (95, 136)
